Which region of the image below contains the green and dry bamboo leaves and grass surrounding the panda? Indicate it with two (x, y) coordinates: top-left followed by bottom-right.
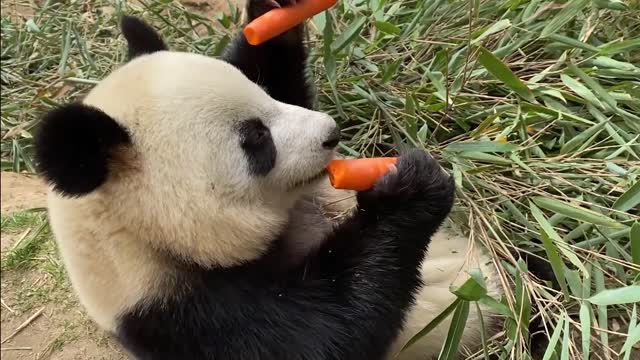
(0, 0), (640, 359)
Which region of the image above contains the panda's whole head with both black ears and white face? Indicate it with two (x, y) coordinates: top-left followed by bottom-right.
(35, 17), (339, 265)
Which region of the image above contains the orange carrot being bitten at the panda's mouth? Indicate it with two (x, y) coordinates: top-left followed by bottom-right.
(327, 157), (398, 191)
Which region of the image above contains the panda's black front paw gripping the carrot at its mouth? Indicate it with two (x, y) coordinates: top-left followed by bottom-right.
(358, 150), (455, 217)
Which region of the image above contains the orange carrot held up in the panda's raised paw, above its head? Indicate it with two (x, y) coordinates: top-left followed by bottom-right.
(243, 0), (337, 45)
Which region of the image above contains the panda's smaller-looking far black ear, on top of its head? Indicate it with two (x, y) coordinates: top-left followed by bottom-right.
(120, 16), (168, 60)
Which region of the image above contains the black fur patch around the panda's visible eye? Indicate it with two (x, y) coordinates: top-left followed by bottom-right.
(238, 119), (277, 176)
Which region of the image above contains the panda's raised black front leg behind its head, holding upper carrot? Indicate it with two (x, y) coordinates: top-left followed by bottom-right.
(222, 0), (313, 109)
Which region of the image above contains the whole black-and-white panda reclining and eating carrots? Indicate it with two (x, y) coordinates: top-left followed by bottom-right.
(35, 0), (508, 360)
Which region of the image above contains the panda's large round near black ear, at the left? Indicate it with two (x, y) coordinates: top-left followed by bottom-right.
(34, 104), (131, 196)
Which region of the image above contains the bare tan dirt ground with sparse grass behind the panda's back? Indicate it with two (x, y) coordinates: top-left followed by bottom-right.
(0, 0), (244, 360)
